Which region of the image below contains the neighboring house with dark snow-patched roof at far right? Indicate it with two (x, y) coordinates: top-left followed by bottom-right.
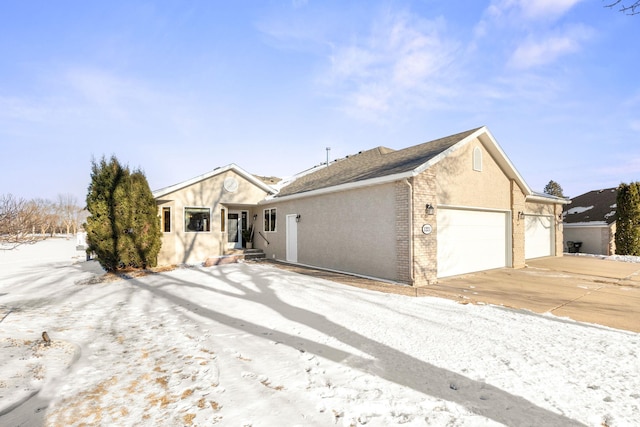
(562, 188), (618, 255)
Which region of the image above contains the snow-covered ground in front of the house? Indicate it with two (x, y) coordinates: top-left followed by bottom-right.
(0, 239), (640, 426)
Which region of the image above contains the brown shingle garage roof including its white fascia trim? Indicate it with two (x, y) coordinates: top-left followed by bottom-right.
(274, 126), (568, 203)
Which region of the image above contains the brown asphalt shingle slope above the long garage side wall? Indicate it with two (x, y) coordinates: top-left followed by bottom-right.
(276, 128), (480, 197)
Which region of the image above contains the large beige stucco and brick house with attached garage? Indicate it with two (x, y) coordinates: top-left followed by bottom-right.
(154, 127), (568, 286)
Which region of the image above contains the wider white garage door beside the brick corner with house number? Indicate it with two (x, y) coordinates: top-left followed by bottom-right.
(437, 208), (509, 277)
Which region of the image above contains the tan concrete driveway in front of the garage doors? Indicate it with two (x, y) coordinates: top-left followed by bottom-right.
(432, 256), (640, 332)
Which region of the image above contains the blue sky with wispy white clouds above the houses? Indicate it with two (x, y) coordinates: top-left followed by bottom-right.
(0, 0), (640, 203)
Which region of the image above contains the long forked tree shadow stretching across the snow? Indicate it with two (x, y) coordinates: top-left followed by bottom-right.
(132, 266), (583, 426)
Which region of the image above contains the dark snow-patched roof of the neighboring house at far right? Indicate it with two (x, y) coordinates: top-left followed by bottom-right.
(562, 187), (618, 225)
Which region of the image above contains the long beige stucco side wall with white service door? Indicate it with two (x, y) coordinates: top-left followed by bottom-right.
(262, 183), (398, 281)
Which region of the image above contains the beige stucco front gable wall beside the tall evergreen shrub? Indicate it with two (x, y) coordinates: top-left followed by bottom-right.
(157, 170), (267, 265)
